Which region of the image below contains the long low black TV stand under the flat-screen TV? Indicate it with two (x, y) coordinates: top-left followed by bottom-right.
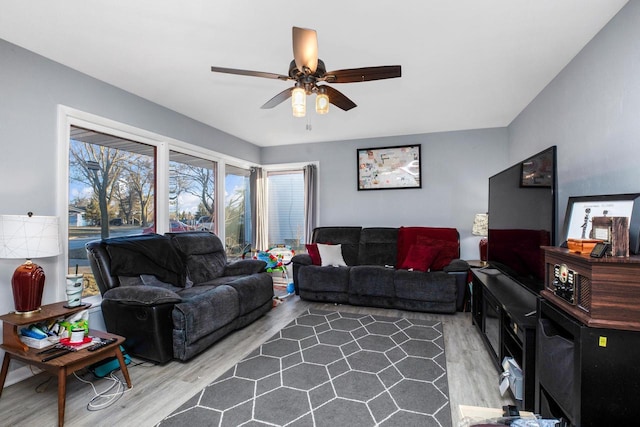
(471, 269), (538, 411)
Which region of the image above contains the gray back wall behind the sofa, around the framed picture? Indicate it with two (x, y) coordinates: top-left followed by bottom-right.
(262, 128), (510, 259)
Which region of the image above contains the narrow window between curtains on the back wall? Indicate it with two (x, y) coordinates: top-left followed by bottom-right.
(267, 170), (304, 251)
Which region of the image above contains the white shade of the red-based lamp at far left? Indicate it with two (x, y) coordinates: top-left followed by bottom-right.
(0, 215), (61, 259)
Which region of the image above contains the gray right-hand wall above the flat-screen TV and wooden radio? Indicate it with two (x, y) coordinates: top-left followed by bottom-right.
(508, 0), (640, 239)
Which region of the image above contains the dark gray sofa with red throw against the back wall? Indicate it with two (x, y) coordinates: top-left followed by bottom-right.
(292, 227), (469, 313)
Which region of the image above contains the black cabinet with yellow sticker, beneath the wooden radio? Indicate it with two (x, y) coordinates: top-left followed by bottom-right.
(536, 300), (640, 427)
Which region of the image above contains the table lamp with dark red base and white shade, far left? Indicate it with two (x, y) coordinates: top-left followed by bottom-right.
(0, 212), (61, 315)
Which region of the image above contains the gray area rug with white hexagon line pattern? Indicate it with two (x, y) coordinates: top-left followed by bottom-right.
(158, 310), (451, 427)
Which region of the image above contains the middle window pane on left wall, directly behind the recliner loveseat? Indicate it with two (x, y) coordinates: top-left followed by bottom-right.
(169, 151), (217, 233)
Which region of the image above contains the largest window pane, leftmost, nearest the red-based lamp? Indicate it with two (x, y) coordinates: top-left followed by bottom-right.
(67, 126), (156, 297)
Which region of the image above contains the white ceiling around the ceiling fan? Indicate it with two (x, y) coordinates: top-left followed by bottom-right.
(0, 0), (627, 146)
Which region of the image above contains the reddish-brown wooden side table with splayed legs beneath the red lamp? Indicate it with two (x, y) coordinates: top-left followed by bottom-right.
(0, 302), (131, 426)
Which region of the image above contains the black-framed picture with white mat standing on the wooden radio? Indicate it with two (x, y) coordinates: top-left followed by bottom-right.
(564, 193), (640, 254)
